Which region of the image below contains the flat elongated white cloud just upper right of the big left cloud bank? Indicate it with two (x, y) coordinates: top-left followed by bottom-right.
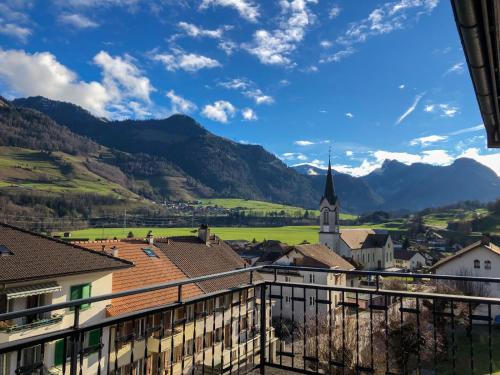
(153, 48), (221, 72)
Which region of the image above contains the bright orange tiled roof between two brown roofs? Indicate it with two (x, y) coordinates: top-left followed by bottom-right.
(81, 240), (203, 316)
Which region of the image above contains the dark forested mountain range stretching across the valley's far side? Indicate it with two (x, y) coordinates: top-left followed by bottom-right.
(0, 97), (500, 213)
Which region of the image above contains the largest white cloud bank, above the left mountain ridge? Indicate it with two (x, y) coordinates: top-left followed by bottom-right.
(0, 50), (154, 118)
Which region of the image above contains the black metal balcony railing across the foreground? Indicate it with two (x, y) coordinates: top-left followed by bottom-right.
(0, 266), (500, 375)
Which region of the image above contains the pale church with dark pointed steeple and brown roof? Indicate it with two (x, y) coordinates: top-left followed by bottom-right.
(319, 160), (394, 270)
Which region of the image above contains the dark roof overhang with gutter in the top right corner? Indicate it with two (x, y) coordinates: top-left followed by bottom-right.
(451, 0), (500, 148)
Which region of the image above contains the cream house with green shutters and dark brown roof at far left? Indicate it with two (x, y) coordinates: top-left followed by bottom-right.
(0, 224), (133, 374)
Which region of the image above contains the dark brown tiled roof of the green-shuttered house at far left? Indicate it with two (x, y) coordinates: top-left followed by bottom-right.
(0, 223), (132, 283)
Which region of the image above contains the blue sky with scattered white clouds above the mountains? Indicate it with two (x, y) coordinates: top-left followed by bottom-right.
(0, 0), (500, 175)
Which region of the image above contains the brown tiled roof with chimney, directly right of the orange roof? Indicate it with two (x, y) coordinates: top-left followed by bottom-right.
(156, 236), (254, 293)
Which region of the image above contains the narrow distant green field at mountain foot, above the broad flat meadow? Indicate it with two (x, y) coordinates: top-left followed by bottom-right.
(200, 198), (356, 220)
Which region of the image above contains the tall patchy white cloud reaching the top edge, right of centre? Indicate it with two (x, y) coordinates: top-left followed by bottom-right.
(242, 0), (317, 65)
